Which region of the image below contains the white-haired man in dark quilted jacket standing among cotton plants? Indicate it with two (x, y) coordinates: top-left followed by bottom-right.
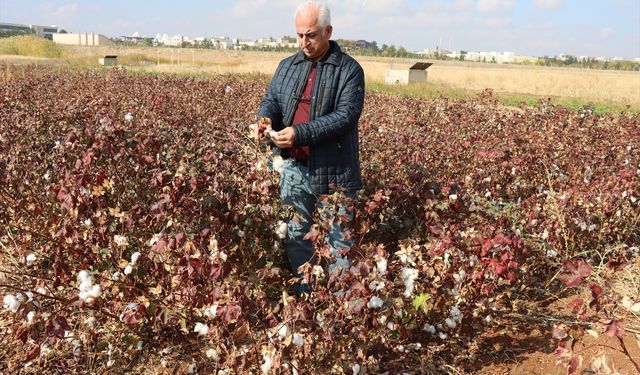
(258, 1), (364, 294)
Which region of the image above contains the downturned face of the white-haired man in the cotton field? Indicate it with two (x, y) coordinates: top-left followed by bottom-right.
(296, 11), (332, 60)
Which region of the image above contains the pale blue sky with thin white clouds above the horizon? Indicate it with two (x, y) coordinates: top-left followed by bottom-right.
(0, 0), (640, 59)
